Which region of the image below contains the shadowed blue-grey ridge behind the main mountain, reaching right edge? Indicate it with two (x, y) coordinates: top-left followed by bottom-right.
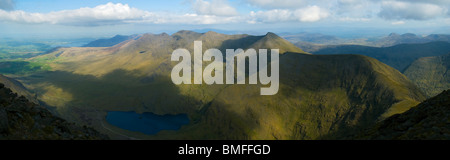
(312, 42), (450, 71)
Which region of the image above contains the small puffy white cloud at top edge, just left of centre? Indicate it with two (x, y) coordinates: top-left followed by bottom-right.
(192, 0), (238, 16)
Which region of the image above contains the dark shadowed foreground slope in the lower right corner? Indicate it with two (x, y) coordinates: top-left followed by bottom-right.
(357, 90), (450, 140)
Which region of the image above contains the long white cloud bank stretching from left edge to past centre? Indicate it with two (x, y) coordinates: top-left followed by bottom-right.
(0, 3), (245, 26)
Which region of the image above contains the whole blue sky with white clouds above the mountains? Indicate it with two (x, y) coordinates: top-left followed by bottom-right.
(0, 0), (450, 38)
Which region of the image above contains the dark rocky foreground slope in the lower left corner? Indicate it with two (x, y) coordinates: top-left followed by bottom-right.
(0, 84), (108, 140)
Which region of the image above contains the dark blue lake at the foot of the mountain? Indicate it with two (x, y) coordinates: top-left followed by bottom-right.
(106, 111), (189, 134)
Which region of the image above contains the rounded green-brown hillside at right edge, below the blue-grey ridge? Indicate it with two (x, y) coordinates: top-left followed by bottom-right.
(404, 54), (450, 97)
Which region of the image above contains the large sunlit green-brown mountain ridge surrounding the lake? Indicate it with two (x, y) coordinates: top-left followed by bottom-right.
(13, 31), (424, 139)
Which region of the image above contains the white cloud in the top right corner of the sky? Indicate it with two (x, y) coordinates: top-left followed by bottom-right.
(378, 0), (448, 20)
